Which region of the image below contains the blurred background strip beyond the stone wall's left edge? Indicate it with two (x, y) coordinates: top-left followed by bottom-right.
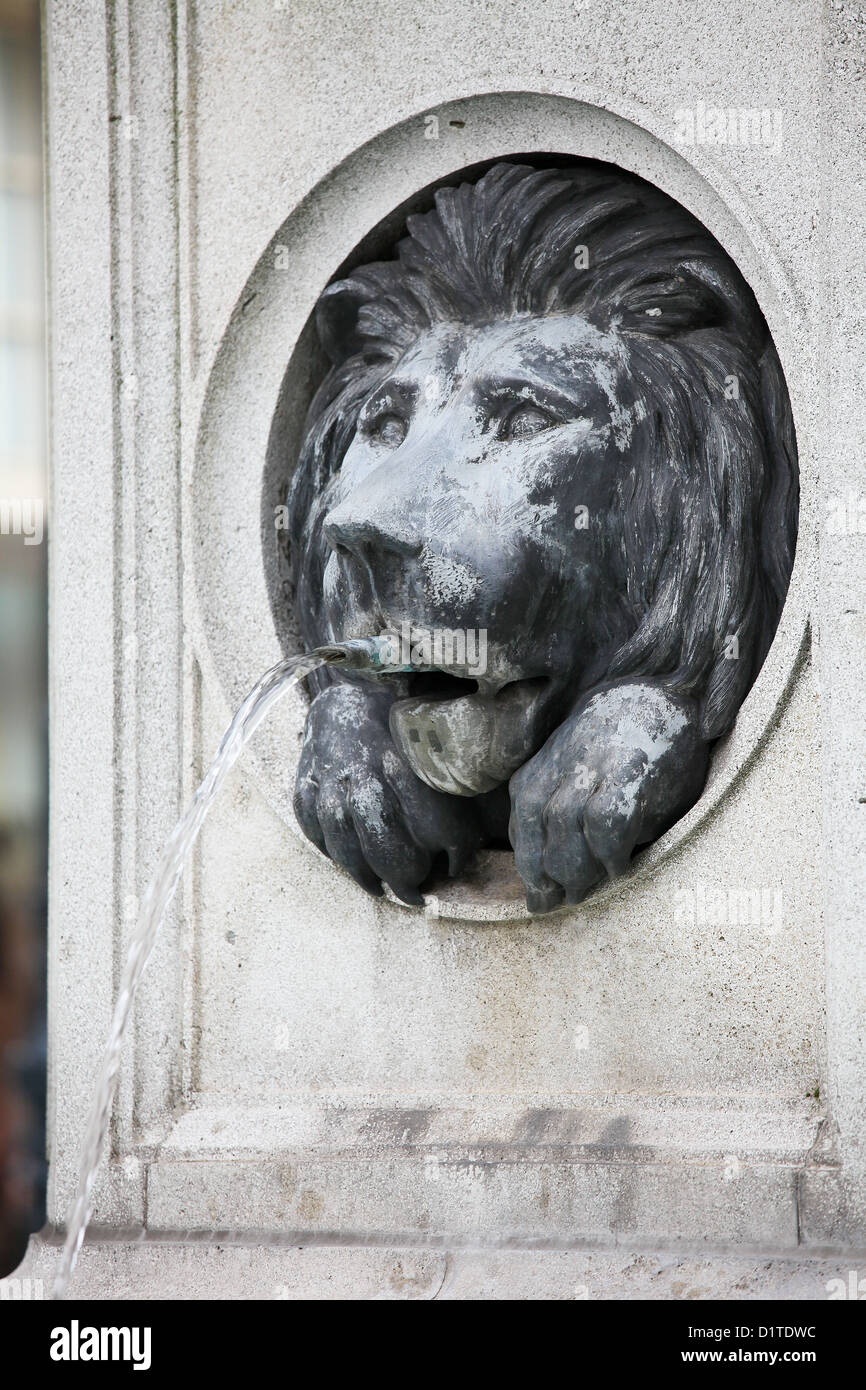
(0, 0), (47, 1276)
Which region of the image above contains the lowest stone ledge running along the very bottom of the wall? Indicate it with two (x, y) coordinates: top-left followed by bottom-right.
(7, 1232), (866, 1301)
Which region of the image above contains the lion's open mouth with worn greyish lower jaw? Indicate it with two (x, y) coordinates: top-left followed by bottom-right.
(391, 670), (550, 796)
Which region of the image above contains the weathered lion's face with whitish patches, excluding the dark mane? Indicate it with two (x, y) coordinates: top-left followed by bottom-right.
(324, 314), (641, 794)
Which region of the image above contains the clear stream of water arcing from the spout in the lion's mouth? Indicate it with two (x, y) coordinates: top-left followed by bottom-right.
(51, 638), (393, 1298)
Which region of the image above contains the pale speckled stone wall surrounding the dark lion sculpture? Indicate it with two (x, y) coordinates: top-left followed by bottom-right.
(22, 0), (866, 1295)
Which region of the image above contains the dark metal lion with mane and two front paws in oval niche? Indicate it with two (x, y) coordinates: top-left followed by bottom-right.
(289, 163), (798, 912)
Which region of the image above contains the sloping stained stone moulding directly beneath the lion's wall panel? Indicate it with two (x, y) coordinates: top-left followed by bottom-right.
(156, 1093), (833, 1165)
